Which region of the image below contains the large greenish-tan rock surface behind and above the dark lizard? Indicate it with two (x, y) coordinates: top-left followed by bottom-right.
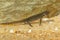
(0, 0), (56, 23)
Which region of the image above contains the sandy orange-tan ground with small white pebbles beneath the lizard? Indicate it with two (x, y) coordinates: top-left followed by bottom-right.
(0, 15), (60, 40)
